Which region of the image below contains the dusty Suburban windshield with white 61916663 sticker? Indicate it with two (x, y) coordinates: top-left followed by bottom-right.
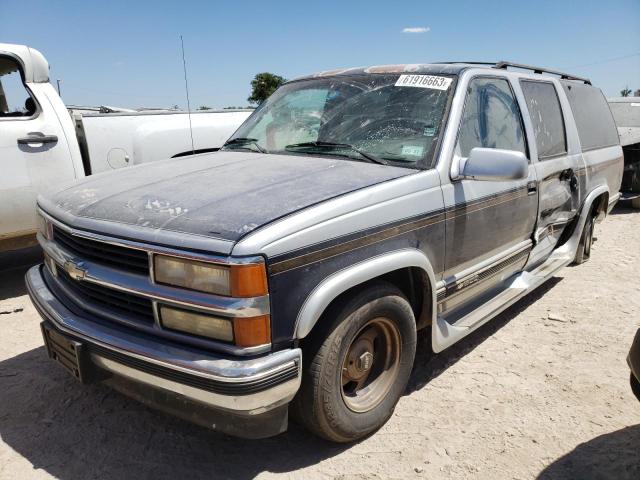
(224, 74), (453, 168)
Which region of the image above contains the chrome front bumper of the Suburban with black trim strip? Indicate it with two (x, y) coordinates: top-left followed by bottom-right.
(26, 265), (302, 438)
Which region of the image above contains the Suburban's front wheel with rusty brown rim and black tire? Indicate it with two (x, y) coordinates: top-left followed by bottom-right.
(292, 283), (416, 442)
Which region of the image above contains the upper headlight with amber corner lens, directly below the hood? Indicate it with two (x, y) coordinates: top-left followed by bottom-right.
(153, 255), (267, 297)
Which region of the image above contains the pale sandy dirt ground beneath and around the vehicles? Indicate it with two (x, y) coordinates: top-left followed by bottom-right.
(0, 209), (640, 480)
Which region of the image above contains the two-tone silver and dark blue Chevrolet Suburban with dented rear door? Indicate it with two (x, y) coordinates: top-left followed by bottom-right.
(26, 62), (623, 442)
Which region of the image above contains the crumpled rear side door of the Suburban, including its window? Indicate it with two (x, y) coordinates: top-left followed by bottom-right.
(520, 79), (582, 263)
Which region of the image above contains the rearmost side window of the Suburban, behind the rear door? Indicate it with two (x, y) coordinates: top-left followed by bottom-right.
(562, 82), (619, 152)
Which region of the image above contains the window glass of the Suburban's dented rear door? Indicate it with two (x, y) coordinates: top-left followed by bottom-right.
(520, 80), (567, 159)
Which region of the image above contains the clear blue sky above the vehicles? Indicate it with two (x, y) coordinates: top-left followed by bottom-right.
(0, 0), (640, 108)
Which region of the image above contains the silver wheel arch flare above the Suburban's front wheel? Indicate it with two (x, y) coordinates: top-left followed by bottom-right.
(294, 248), (436, 339)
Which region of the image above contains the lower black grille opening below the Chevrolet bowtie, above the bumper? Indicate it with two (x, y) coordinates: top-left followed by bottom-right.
(57, 268), (154, 325)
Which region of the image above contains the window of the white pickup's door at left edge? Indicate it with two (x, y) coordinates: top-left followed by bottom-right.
(0, 57), (36, 118)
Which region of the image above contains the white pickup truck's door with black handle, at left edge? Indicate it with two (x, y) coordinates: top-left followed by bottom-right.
(0, 55), (76, 251)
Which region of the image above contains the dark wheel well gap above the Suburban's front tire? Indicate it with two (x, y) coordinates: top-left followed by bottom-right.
(314, 267), (433, 338)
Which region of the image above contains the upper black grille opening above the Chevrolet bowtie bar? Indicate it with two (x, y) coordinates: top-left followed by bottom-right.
(53, 225), (149, 275)
